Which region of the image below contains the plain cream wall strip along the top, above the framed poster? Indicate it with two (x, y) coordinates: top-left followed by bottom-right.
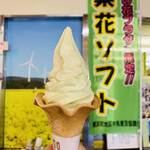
(0, 0), (150, 17)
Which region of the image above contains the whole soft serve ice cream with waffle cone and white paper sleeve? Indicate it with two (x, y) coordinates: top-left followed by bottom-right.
(34, 27), (100, 150)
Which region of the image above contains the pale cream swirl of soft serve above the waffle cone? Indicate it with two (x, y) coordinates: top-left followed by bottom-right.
(42, 27), (94, 111)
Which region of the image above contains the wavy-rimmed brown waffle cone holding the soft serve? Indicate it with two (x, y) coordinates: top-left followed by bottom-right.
(34, 93), (100, 138)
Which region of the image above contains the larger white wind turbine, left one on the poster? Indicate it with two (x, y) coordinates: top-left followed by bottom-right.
(20, 53), (38, 82)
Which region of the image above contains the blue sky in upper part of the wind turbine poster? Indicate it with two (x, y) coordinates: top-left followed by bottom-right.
(6, 17), (82, 78)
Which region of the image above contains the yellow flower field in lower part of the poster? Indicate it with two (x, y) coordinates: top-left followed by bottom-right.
(4, 89), (52, 148)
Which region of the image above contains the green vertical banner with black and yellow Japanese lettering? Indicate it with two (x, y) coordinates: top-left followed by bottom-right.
(88, 0), (140, 134)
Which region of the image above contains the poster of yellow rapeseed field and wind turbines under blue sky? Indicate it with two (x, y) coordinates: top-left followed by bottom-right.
(4, 17), (82, 148)
